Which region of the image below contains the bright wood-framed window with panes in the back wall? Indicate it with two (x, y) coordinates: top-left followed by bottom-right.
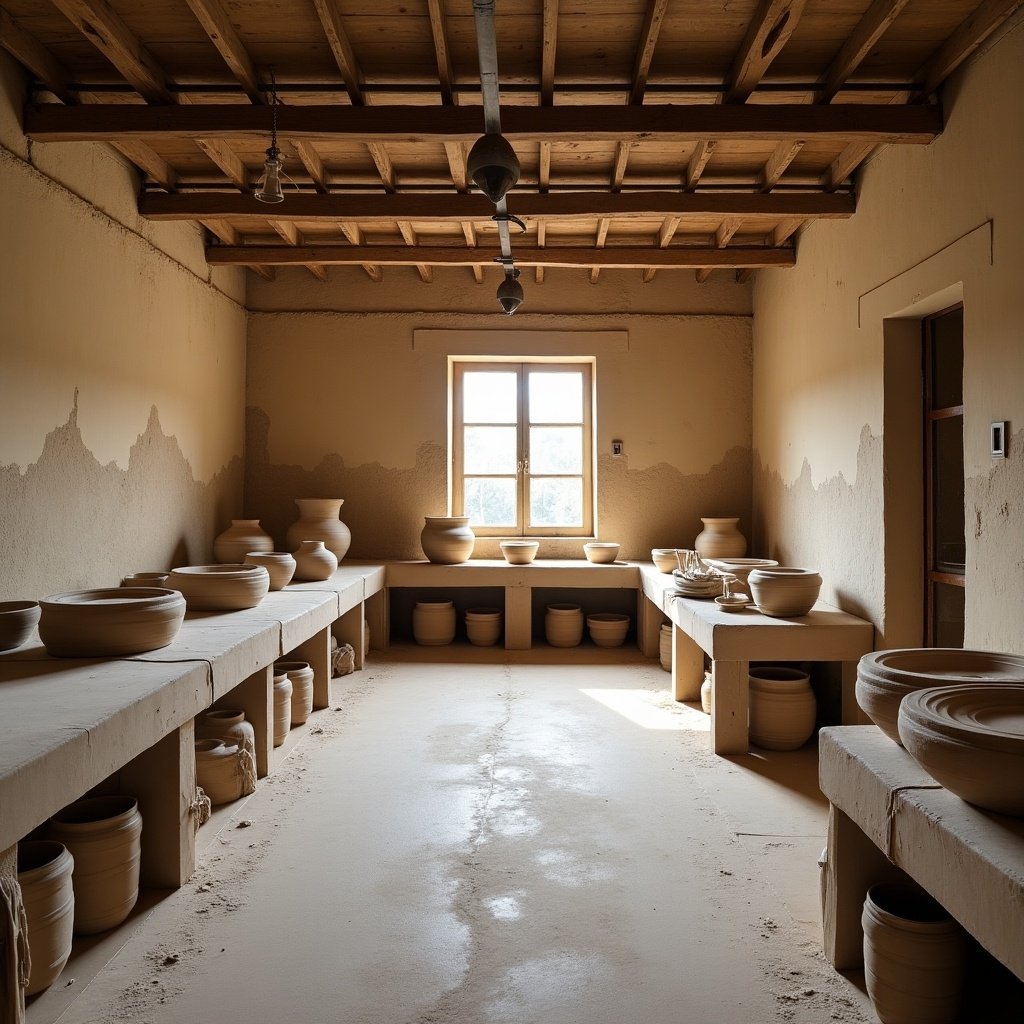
(452, 360), (594, 537)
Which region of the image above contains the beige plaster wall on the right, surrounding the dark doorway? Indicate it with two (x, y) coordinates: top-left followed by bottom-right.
(754, 15), (1024, 653)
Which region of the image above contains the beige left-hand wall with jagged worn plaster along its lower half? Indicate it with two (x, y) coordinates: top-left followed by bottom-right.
(0, 53), (246, 599)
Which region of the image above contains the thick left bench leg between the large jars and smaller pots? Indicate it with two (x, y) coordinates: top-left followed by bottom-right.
(121, 719), (196, 889)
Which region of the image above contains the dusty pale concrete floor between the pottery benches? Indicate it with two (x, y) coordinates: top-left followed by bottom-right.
(29, 646), (872, 1024)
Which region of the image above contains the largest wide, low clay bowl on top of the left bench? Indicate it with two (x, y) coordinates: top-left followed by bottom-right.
(39, 587), (185, 657)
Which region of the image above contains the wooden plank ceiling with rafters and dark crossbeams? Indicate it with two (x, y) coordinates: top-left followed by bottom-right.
(0, 0), (1024, 282)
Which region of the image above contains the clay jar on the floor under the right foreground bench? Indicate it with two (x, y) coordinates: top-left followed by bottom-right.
(861, 885), (965, 1024)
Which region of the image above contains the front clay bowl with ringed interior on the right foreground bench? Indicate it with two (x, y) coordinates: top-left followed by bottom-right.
(897, 683), (1024, 817)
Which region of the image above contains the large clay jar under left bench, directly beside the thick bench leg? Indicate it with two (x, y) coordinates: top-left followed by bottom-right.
(49, 795), (142, 935)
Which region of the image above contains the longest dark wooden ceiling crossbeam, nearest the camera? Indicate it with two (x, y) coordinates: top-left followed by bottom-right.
(25, 103), (942, 145)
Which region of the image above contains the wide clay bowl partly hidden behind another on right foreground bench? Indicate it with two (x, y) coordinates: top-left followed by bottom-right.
(854, 647), (1024, 743)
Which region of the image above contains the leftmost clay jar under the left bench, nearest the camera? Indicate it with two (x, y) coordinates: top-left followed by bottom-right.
(17, 840), (75, 995)
